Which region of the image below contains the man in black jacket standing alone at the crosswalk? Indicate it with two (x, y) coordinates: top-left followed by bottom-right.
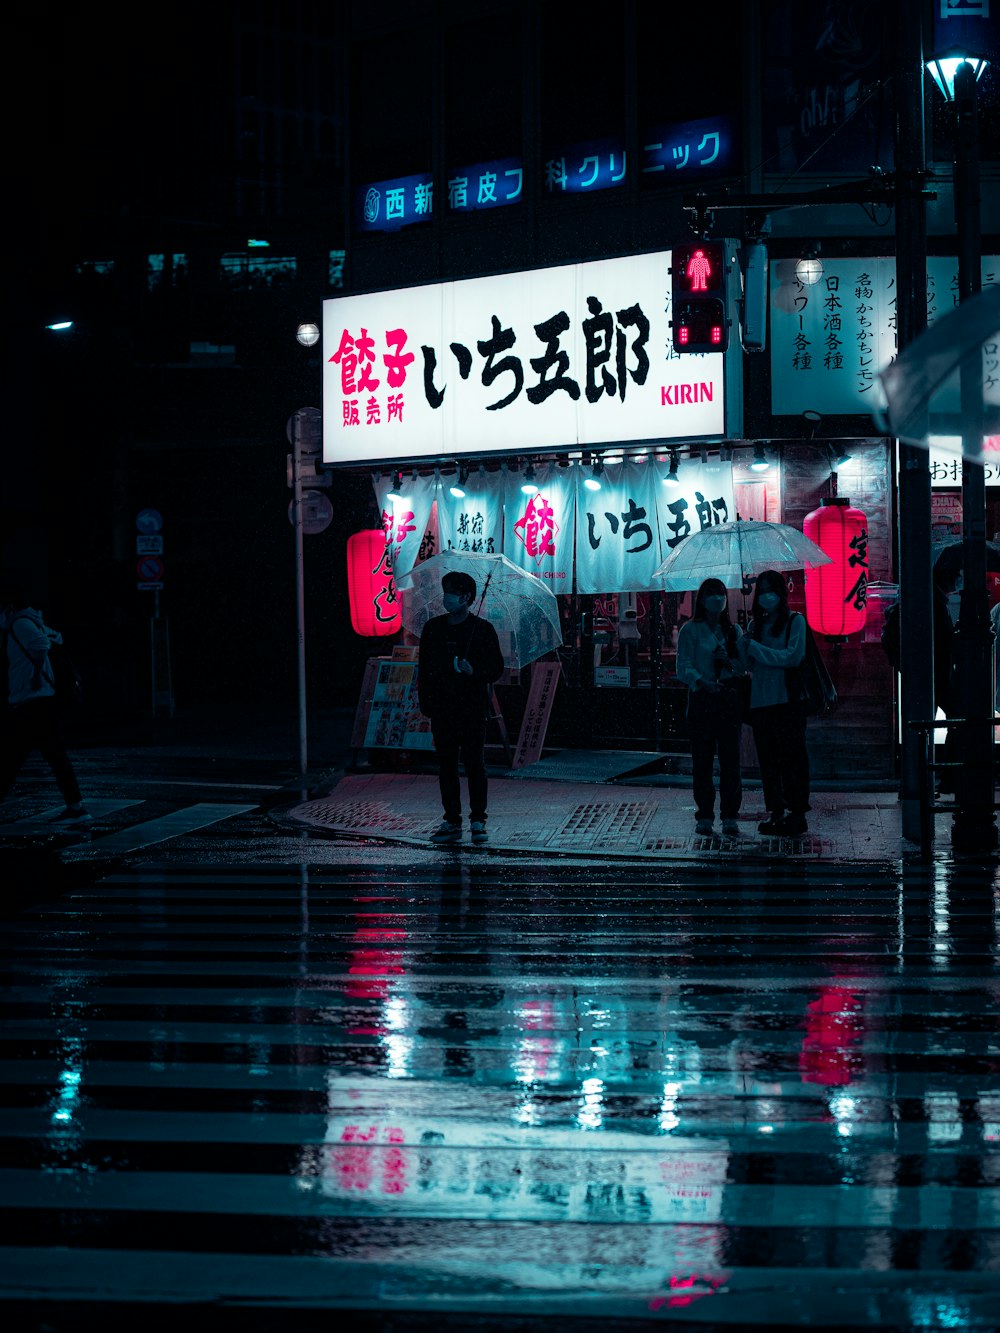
(417, 572), (504, 844)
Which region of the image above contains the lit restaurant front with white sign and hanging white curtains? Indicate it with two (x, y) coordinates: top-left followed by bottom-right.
(324, 252), (917, 777)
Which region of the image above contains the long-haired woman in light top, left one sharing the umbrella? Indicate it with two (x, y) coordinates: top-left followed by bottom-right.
(677, 579), (745, 837)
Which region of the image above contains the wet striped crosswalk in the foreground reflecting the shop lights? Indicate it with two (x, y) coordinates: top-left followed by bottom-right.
(0, 858), (1000, 1329)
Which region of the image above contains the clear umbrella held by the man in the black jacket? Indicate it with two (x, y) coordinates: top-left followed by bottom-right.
(397, 551), (563, 667)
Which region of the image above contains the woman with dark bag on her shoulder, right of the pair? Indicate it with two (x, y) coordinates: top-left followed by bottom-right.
(740, 569), (809, 837)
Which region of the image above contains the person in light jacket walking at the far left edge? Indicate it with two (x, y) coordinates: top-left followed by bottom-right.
(0, 581), (91, 826)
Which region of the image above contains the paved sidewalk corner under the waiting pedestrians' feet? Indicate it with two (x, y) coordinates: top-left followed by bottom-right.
(283, 750), (917, 864)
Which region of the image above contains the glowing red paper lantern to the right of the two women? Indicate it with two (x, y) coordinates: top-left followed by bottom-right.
(803, 499), (868, 636)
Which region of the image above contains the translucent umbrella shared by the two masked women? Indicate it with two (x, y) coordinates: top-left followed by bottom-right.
(653, 519), (831, 592)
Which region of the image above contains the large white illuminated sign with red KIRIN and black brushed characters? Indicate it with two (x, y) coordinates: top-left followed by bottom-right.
(323, 252), (727, 464)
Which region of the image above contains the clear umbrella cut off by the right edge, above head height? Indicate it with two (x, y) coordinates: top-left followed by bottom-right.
(873, 287), (1000, 461)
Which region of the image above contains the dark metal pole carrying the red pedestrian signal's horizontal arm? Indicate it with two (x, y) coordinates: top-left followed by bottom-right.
(895, 0), (933, 845)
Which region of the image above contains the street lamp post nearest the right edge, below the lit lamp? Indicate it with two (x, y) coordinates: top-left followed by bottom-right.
(952, 61), (997, 850)
